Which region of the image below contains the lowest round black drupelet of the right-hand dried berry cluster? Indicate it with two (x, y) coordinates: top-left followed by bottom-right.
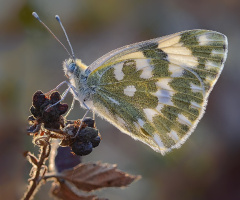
(72, 140), (93, 156)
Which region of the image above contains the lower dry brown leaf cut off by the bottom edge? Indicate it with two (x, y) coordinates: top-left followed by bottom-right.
(51, 181), (107, 200)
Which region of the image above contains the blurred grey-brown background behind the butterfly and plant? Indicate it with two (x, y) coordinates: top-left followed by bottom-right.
(0, 0), (240, 200)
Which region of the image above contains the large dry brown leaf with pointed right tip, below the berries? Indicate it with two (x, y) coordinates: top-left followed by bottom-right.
(52, 162), (140, 192)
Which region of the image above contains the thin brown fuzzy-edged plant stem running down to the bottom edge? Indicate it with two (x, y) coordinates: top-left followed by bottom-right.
(22, 136), (51, 200)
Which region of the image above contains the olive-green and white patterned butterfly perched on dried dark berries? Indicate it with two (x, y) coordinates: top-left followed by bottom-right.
(33, 12), (228, 155)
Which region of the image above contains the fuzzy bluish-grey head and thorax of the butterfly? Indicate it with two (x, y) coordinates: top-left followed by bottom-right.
(63, 59), (94, 107)
